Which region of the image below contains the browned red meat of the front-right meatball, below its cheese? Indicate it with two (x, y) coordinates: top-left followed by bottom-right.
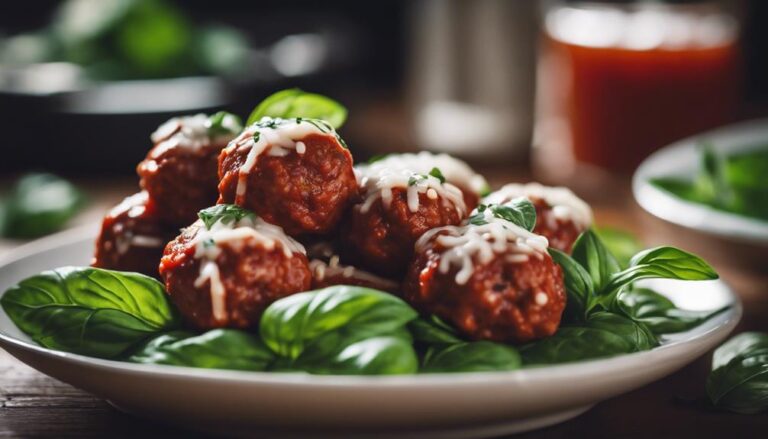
(403, 225), (566, 343)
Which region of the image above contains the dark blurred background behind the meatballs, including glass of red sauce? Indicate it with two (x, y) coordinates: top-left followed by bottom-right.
(0, 0), (768, 251)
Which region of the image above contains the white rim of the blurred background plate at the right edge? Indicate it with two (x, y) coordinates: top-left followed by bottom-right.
(632, 118), (768, 244)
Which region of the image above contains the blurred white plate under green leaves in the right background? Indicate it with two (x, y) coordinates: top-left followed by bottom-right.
(632, 119), (768, 245)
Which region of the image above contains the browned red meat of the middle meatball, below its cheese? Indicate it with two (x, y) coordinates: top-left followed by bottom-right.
(342, 188), (464, 277)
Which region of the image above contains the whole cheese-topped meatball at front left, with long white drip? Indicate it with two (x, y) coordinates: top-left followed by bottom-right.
(160, 210), (311, 329)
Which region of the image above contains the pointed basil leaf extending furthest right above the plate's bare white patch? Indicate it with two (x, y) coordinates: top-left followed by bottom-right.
(600, 247), (718, 296)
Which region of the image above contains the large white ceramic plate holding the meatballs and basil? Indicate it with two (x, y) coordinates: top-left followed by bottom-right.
(0, 228), (741, 438)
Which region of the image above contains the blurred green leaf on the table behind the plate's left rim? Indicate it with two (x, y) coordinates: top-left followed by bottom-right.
(0, 174), (84, 238)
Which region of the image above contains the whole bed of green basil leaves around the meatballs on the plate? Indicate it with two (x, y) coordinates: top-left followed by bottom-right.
(0, 227), (722, 375)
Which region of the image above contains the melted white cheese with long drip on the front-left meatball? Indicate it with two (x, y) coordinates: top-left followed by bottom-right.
(192, 216), (306, 321)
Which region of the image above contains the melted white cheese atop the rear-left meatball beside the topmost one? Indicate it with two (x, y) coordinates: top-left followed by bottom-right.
(150, 113), (238, 155)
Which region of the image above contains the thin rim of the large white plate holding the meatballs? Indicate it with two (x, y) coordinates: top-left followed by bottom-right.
(0, 224), (743, 389)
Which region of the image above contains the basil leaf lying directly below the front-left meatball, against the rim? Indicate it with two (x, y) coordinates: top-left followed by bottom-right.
(128, 329), (274, 371)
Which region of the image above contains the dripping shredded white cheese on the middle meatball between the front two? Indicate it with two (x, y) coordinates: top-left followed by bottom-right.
(355, 167), (467, 217)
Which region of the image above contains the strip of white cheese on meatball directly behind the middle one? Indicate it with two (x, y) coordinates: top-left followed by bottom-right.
(355, 151), (488, 195)
